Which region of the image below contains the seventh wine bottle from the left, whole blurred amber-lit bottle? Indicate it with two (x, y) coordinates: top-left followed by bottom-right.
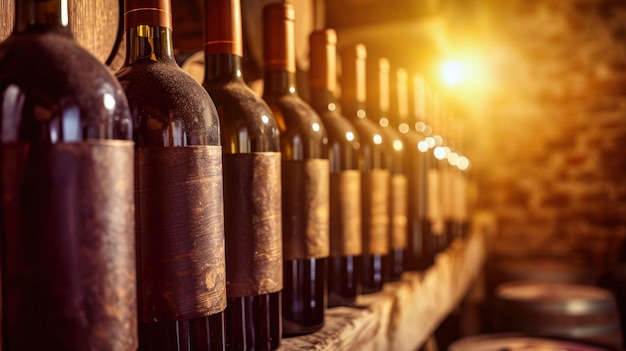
(367, 57), (408, 281)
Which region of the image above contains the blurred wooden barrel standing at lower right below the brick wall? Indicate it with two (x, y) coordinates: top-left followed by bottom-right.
(494, 282), (622, 349)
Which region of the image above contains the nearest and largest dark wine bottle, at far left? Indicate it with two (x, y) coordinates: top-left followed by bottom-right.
(0, 0), (137, 350)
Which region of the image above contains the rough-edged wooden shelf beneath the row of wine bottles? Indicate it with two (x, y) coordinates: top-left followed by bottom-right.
(279, 223), (486, 351)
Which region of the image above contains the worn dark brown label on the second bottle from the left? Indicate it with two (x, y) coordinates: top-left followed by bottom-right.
(137, 146), (226, 322)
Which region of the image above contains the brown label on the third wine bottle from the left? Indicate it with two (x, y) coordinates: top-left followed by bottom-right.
(223, 152), (283, 297)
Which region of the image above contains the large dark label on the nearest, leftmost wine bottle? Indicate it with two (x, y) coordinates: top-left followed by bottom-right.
(0, 140), (137, 350)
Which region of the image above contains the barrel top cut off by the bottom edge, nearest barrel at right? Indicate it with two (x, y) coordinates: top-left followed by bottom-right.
(448, 334), (609, 351)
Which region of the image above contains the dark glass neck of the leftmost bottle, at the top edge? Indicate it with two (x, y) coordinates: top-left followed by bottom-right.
(13, 0), (71, 35)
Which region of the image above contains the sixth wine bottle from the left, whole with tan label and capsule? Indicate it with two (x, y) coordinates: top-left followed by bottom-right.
(340, 44), (390, 294)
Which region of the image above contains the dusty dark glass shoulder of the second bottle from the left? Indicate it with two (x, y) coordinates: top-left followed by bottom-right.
(116, 59), (220, 146)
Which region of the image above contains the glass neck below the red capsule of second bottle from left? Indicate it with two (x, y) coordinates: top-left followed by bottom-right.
(125, 25), (176, 65)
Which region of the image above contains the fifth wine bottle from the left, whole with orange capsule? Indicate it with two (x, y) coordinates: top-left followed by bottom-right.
(309, 29), (362, 307)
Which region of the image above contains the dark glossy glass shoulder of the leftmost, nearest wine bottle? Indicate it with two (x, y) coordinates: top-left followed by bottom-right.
(0, 31), (132, 142)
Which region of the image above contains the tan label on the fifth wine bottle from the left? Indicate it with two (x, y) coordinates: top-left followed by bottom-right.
(330, 170), (362, 257)
